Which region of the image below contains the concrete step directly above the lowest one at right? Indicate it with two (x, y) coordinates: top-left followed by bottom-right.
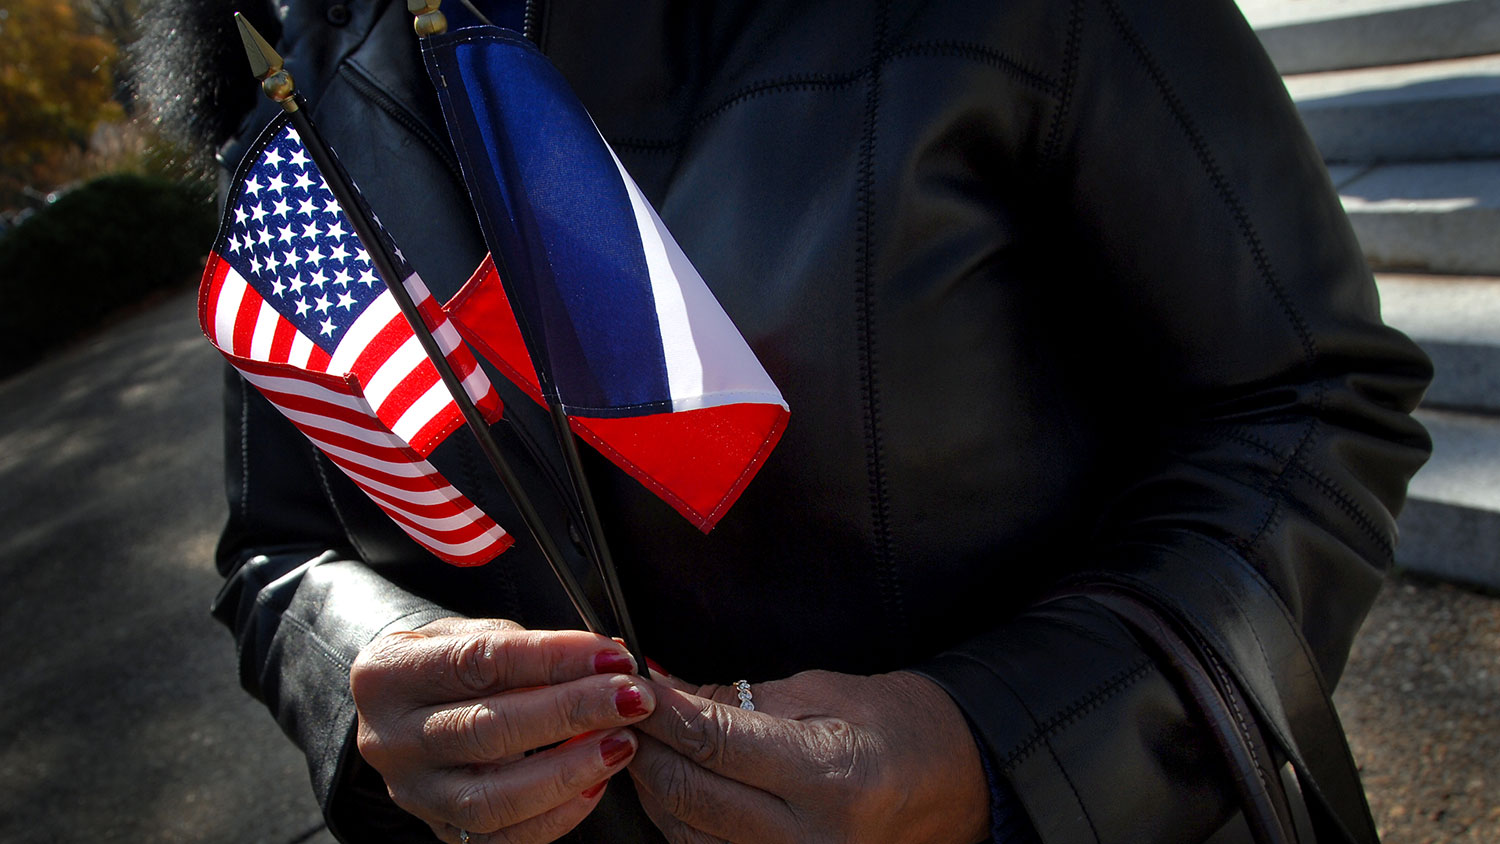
(1376, 274), (1500, 415)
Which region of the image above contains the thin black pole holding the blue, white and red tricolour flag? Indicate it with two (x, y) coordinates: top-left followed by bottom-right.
(407, 0), (647, 672)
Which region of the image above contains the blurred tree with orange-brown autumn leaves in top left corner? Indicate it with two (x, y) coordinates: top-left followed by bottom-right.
(0, 0), (123, 208)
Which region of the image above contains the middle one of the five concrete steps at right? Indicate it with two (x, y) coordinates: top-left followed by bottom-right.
(1329, 159), (1500, 276)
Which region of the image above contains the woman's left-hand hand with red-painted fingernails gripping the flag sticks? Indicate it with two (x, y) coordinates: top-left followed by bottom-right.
(350, 618), (656, 844)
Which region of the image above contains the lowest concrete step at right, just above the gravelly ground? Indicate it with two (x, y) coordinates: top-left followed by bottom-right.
(1397, 411), (1500, 589)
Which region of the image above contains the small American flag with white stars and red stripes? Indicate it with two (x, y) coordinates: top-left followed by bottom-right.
(198, 115), (513, 565)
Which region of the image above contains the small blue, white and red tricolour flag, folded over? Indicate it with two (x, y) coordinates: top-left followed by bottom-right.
(423, 27), (788, 532)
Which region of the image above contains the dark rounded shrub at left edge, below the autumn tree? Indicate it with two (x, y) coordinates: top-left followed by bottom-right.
(0, 174), (216, 375)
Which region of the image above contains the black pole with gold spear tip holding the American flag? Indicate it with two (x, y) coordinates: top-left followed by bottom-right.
(234, 12), (609, 638)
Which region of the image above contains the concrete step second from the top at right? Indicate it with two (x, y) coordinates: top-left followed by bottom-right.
(1284, 54), (1500, 162)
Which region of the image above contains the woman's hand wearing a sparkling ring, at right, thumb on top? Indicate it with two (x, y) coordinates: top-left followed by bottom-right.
(630, 672), (990, 844)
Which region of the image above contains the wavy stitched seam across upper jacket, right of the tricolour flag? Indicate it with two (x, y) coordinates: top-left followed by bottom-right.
(611, 40), (1059, 153)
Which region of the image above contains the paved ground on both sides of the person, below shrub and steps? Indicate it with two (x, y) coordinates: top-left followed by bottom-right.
(0, 292), (1500, 844)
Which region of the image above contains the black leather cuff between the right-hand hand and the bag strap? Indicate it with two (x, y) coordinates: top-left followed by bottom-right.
(917, 598), (1230, 844)
